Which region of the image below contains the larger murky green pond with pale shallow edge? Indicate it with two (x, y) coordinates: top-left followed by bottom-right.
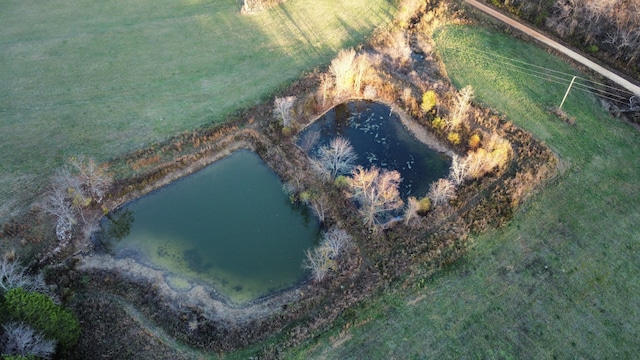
(99, 150), (319, 303)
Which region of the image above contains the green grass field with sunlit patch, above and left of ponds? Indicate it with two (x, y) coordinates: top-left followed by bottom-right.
(0, 0), (396, 222)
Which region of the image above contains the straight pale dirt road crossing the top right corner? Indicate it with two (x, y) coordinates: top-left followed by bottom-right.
(465, 0), (640, 97)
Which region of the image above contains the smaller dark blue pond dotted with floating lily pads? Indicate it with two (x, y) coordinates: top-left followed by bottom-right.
(298, 101), (451, 201)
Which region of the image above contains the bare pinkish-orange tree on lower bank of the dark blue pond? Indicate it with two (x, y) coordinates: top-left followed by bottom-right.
(348, 166), (403, 228)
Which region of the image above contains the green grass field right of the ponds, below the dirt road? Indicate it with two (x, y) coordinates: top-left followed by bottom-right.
(286, 26), (640, 359)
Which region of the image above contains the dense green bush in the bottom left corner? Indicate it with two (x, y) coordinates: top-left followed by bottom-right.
(1, 288), (80, 351)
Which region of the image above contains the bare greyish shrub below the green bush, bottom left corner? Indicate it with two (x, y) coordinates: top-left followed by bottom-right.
(0, 322), (56, 359)
